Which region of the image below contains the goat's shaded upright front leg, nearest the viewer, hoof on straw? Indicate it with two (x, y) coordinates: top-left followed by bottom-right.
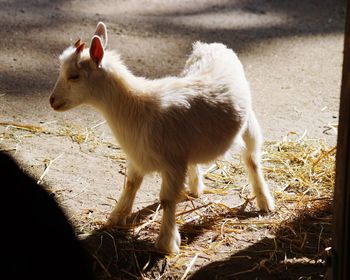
(156, 168), (186, 254)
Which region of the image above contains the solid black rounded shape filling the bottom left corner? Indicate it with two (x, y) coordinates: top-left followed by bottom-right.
(0, 152), (95, 280)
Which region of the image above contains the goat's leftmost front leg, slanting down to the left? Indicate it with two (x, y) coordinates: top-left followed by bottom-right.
(107, 163), (143, 227)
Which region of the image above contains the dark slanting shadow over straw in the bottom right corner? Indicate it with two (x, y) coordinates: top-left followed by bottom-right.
(190, 203), (332, 280)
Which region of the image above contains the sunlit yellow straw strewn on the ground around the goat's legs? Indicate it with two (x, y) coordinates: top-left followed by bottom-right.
(0, 122), (336, 279)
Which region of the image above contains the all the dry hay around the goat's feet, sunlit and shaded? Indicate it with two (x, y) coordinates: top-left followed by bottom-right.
(0, 123), (336, 279)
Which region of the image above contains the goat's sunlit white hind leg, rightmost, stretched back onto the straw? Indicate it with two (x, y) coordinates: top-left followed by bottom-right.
(242, 112), (275, 212)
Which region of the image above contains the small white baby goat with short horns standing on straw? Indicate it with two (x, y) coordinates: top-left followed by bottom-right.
(50, 22), (274, 253)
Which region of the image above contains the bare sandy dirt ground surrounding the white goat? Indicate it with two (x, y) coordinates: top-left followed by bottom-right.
(0, 0), (345, 279)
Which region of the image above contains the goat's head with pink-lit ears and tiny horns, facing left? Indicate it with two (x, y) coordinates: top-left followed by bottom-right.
(50, 22), (107, 111)
